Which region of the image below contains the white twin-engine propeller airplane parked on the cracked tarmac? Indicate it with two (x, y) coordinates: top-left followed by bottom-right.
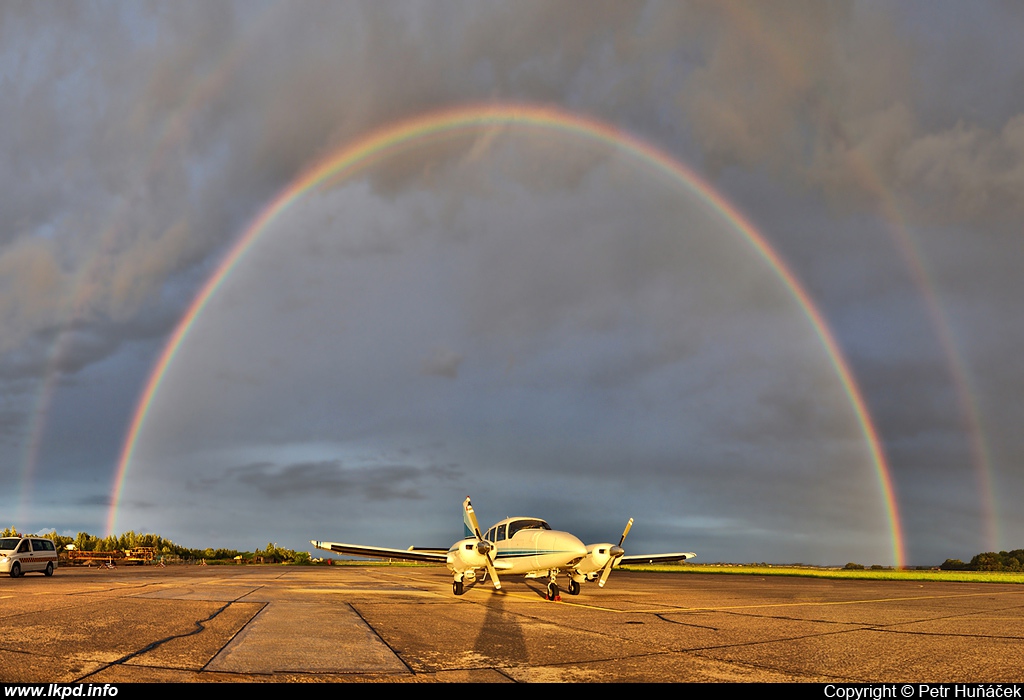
(310, 497), (696, 601)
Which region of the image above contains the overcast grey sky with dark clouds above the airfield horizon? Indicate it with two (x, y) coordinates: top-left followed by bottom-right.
(0, 1), (1024, 564)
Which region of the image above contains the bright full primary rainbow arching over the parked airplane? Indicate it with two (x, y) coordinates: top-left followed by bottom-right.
(106, 103), (904, 566)
